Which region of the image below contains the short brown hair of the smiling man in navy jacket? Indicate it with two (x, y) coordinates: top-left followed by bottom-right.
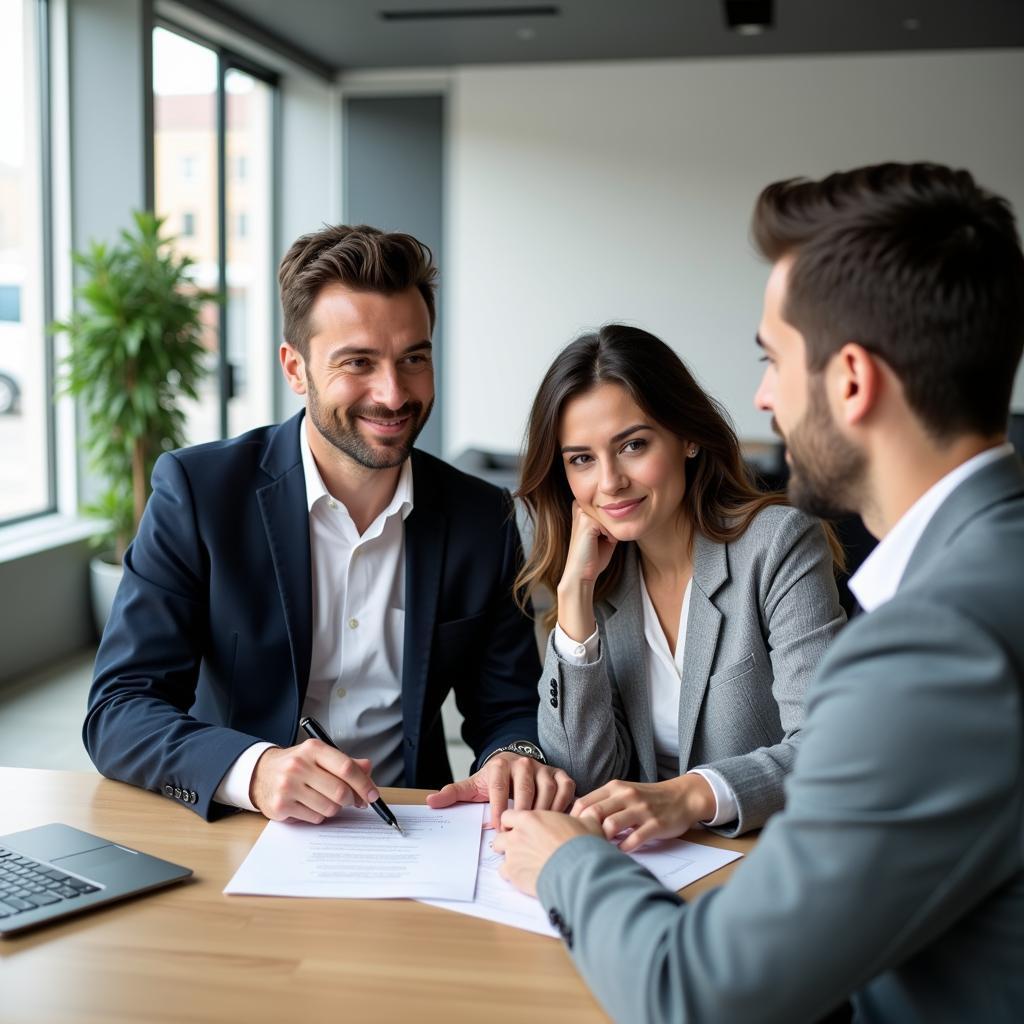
(278, 224), (437, 357)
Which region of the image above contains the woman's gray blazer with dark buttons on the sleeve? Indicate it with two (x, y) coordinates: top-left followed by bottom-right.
(538, 505), (846, 836)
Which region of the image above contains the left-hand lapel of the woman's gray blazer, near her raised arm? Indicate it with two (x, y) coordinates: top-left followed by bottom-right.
(602, 551), (657, 782)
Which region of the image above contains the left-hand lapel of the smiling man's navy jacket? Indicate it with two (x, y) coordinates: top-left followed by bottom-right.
(256, 414), (312, 708)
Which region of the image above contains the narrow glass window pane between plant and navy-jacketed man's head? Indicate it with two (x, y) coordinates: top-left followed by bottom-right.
(224, 69), (276, 434)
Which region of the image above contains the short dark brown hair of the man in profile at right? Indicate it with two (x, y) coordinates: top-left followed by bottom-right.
(753, 163), (1024, 439)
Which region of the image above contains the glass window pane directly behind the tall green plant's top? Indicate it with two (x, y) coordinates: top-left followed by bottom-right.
(153, 29), (220, 444)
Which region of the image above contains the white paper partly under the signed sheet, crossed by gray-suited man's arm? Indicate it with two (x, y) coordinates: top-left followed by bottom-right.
(422, 829), (742, 938)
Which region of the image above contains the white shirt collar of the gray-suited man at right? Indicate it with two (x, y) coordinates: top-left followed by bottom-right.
(849, 442), (1014, 611)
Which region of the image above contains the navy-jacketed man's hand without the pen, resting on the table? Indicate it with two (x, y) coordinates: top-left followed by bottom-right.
(427, 751), (575, 828)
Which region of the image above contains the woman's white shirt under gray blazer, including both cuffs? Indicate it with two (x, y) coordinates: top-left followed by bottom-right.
(555, 573), (738, 825)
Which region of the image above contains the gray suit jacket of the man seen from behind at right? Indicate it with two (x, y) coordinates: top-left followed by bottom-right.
(539, 456), (1024, 1024)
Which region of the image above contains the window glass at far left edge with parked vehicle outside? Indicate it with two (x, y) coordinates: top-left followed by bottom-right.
(0, 0), (54, 522)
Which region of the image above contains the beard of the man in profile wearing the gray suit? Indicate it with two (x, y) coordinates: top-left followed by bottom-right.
(772, 378), (867, 519)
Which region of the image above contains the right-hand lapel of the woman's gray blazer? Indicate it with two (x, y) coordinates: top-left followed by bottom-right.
(679, 534), (729, 774)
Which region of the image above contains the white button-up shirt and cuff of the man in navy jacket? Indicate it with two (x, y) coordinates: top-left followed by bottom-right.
(214, 422), (413, 811)
